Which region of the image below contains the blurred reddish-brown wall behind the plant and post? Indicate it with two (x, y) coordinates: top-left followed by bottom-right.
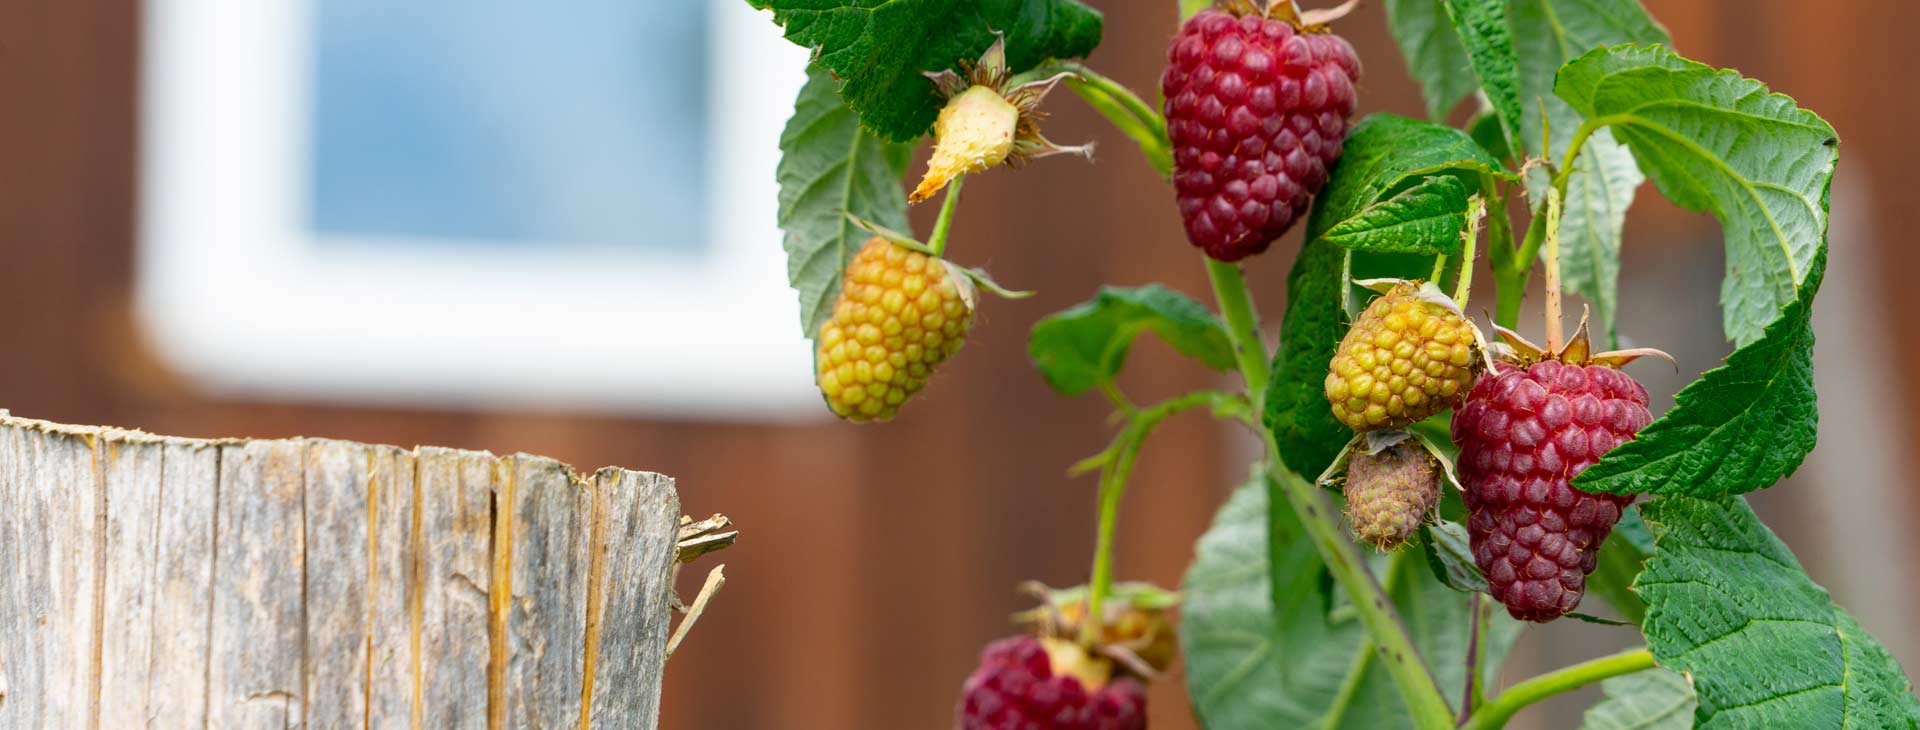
(0, 0), (1920, 730)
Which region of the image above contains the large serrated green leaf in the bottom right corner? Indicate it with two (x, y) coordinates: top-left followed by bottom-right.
(1634, 498), (1920, 730)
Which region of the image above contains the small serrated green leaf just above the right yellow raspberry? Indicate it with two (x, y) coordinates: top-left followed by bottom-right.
(1325, 175), (1469, 256)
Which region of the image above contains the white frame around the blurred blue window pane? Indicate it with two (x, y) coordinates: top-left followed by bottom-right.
(136, 0), (826, 419)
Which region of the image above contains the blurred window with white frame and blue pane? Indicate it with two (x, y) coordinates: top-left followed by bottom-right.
(138, 0), (818, 417)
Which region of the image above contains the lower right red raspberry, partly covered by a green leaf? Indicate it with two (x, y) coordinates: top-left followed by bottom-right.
(1453, 359), (1653, 622)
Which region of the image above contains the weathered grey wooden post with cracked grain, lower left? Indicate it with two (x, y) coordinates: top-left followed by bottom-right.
(0, 411), (680, 730)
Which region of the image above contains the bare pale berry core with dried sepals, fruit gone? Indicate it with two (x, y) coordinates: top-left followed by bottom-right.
(906, 37), (1092, 204)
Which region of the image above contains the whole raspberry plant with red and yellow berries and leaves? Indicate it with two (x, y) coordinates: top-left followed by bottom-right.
(749, 0), (1920, 728)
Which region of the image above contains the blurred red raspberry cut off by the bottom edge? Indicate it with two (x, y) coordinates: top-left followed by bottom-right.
(954, 636), (1146, 730)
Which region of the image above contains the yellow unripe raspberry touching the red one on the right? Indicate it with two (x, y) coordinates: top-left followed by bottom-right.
(1327, 282), (1476, 432)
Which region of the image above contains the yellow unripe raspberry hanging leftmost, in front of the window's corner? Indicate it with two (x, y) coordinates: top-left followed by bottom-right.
(814, 236), (973, 421)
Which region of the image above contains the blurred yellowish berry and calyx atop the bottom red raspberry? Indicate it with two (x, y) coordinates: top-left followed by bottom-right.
(1014, 582), (1181, 684)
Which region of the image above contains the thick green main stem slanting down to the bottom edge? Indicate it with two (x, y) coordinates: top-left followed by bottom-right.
(1206, 259), (1453, 730)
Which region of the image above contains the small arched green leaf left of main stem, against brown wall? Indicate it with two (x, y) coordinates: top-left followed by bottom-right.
(1027, 284), (1235, 396)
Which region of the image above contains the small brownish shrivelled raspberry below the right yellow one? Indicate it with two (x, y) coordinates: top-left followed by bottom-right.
(1344, 440), (1440, 549)
